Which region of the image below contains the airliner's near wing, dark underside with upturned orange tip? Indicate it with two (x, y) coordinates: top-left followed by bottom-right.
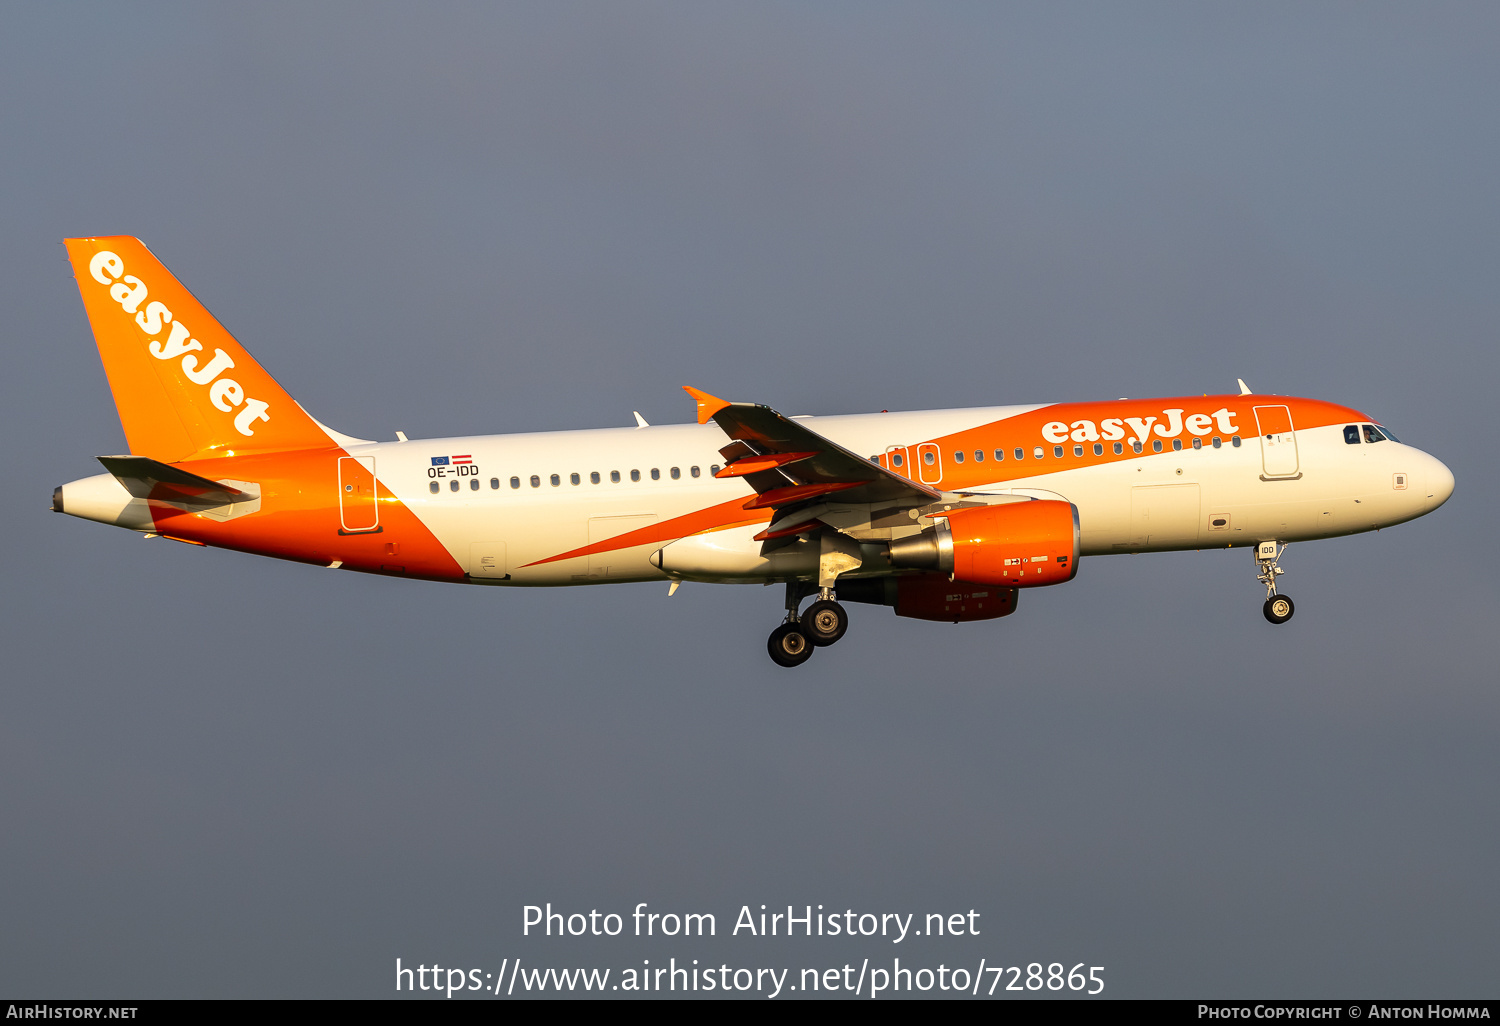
(684, 386), (941, 519)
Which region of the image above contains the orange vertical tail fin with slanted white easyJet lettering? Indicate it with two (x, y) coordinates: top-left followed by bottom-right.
(65, 236), (333, 464)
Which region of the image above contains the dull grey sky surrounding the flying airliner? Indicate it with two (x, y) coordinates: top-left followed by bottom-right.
(0, 2), (1500, 998)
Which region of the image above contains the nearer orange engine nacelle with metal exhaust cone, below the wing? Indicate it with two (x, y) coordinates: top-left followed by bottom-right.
(890, 500), (1079, 588)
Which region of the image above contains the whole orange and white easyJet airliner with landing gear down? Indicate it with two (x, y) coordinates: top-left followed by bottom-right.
(53, 236), (1454, 666)
